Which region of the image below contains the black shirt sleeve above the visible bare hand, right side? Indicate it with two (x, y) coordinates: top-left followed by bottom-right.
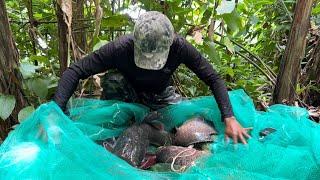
(179, 38), (233, 119)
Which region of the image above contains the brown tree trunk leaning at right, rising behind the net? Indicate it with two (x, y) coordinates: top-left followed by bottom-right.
(273, 0), (313, 104)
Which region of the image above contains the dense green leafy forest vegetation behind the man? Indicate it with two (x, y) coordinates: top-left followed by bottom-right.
(0, 0), (320, 140)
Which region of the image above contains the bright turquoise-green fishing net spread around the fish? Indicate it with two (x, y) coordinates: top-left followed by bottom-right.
(0, 90), (320, 180)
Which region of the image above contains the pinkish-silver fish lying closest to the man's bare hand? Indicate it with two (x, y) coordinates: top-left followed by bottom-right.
(174, 117), (218, 147)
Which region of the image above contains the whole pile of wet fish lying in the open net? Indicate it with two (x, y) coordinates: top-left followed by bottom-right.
(100, 112), (217, 172)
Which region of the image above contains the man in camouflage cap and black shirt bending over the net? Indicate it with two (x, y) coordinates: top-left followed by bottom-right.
(54, 11), (249, 144)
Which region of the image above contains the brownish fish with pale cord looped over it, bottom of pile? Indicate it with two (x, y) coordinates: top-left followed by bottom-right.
(156, 146), (207, 171)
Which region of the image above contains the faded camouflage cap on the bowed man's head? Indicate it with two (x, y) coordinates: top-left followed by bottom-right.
(134, 11), (174, 70)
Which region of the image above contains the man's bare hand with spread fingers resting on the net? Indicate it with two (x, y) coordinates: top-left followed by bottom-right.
(224, 116), (251, 144)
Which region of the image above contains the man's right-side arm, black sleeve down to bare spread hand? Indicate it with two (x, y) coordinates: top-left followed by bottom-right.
(176, 38), (250, 144)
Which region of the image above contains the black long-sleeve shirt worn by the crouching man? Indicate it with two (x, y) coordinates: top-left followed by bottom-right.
(54, 35), (233, 118)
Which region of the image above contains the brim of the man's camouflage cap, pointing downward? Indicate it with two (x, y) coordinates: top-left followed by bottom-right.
(134, 48), (170, 70)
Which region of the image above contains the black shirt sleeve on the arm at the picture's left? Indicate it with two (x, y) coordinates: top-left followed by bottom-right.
(53, 38), (119, 110)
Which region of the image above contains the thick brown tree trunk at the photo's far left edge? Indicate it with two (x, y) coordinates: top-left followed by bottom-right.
(0, 0), (27, 139)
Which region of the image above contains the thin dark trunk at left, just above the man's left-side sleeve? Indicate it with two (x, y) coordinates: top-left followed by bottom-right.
(56, 4), (68, 76)
